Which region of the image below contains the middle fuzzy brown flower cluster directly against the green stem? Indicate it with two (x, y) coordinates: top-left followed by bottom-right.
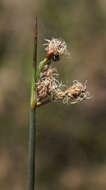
(36, 65), (63, 106)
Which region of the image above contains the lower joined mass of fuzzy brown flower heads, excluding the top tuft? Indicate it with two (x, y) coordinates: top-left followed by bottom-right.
(36, 65), (90, 106)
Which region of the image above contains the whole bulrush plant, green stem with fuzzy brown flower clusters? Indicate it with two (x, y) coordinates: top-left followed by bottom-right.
(29, 18), (90, 190)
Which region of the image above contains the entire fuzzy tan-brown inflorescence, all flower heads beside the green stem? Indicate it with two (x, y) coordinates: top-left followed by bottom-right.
(35, 38), (90, 107)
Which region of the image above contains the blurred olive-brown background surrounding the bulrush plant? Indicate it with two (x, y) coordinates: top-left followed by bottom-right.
(0, 0), (106, 190)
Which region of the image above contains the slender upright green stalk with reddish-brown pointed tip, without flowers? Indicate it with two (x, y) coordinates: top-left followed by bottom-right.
(28, 17), (37, 190)
